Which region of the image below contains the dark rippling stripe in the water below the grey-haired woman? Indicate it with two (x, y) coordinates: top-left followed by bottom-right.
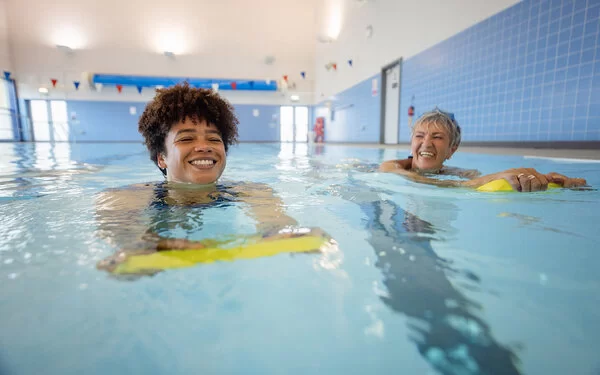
(330, 181), (520, 374)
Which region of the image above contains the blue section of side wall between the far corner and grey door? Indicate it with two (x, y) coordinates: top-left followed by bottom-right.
(311, 74), (381, 143)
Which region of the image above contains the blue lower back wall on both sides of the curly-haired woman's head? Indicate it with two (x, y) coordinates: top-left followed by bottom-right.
(61, 101), (279, 142)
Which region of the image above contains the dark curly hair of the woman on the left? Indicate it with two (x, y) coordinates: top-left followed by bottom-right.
(138, 82), (239, 175)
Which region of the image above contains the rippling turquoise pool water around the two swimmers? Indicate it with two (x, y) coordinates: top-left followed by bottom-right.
(0, 143), (600, 374)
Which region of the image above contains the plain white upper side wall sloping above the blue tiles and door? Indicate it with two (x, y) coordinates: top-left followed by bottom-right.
(315, 0), (519, 102)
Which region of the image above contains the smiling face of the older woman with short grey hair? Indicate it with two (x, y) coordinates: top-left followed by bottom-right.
(410, 122), (457, 173)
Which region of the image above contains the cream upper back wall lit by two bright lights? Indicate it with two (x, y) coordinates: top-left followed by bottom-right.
(5, 0), (320, 103)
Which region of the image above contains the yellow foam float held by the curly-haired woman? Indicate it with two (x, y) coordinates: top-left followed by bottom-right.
(112, 236), (329, 274)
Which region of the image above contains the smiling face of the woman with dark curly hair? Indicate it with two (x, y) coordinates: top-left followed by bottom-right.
(157, 118), (227, 185)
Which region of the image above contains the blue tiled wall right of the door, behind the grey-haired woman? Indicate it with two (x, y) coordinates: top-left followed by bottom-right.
(400, 0), (600, 142)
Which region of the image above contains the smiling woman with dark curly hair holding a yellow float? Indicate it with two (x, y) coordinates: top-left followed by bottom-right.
(97, 83), (336, 275)
